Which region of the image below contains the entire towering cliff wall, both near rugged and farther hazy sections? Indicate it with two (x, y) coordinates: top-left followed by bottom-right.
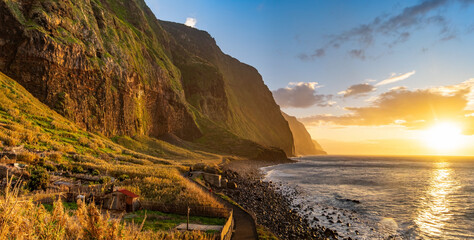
(0, 0), (293, 157)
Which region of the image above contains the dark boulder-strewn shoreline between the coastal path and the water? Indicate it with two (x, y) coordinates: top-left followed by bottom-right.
(223, 161), (341, 239)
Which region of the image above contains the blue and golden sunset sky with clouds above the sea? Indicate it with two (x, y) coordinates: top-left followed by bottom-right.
(146, 0), (474, 155)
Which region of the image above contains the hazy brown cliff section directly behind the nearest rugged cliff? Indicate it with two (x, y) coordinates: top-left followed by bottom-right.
(160, 21), (294, 155)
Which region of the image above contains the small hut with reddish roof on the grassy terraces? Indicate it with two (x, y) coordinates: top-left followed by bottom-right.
(104, 189), (139, 212)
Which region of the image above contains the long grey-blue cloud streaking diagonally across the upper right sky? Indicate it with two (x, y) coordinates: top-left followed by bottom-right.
(299, 0), (474, 60)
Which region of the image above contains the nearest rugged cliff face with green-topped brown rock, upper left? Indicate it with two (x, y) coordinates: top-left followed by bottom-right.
(0, 0), (201, 139)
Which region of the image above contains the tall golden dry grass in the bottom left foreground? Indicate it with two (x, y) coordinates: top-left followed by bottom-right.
(0, 175), (214, 240)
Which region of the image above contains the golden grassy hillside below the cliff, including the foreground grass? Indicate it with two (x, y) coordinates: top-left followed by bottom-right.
(0, 72), (222, 239)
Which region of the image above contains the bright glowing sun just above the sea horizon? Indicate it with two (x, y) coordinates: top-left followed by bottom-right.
(423, 122), (463, 152)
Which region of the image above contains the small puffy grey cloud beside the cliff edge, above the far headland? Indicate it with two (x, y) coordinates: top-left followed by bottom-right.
(273, 82), (332, 108)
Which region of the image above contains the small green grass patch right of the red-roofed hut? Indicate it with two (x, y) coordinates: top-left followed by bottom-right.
(124, 210), (226, 231)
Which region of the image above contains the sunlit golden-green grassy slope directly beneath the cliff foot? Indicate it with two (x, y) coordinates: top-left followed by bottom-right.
(0, 72), (221, 206)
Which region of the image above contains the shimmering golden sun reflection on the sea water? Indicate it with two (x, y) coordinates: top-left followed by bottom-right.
(415, 162), (458, 238)
